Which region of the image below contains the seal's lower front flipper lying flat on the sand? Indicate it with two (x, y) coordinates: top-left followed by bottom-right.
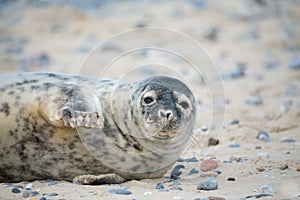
(73, 174), (127, 185)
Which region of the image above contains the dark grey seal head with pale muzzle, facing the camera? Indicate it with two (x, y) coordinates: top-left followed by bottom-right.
(131, 76), (195, 140)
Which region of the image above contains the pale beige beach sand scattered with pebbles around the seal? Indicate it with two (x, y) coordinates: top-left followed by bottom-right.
(0, 0), (300, 199)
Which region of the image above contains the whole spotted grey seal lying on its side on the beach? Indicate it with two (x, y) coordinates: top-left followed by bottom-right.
(0, 73), (196, 184)
